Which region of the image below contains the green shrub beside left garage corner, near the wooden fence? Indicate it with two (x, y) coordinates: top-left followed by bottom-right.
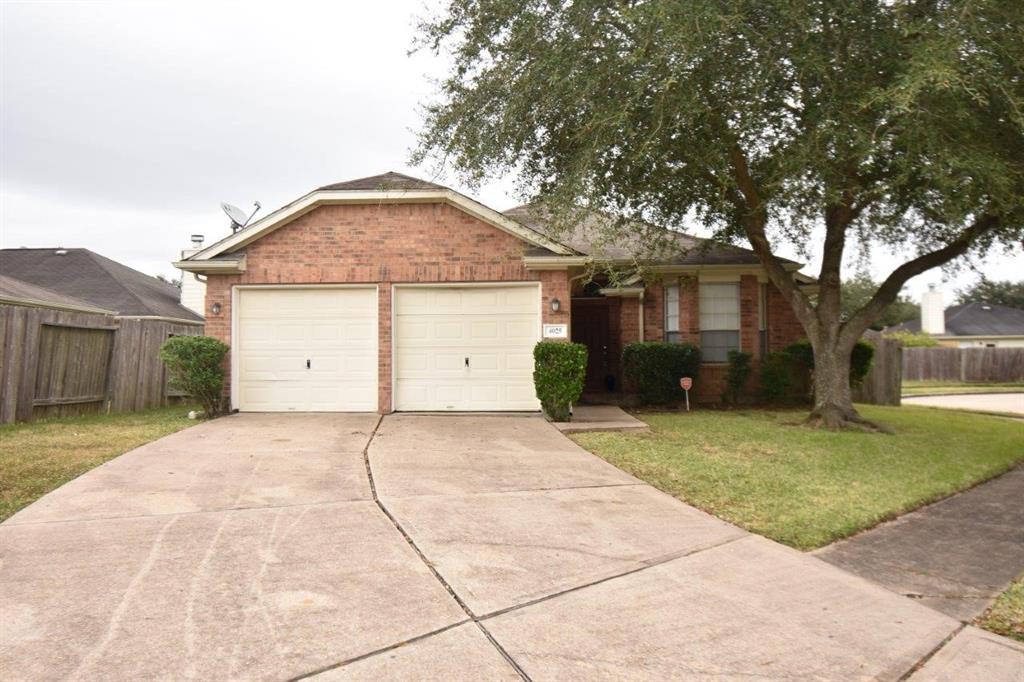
(160, 336), (227, 417)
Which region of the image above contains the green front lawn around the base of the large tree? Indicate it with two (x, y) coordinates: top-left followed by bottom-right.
(572, 406), (1024, 550)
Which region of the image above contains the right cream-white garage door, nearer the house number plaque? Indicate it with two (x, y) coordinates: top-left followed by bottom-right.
(393, 285), (541, 412)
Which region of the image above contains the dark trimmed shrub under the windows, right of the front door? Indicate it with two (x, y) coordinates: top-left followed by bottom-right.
(623, 341), (700, 404)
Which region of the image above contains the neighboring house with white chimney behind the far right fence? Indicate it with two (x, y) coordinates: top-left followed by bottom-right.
(886, 287), (1024, 348)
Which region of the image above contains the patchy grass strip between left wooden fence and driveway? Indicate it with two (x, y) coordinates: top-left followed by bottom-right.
(0, 406), (196, 521)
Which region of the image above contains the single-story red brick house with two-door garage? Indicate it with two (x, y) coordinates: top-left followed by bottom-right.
(175, 173), (815, 413)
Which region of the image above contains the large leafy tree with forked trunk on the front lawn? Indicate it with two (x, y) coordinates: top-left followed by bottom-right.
(414, 0), (1024, 427)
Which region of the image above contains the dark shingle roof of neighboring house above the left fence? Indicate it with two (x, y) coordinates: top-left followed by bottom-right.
(0, 249), (203, 323)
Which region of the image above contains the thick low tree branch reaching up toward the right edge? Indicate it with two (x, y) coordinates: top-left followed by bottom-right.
(842, 212), (999, 346)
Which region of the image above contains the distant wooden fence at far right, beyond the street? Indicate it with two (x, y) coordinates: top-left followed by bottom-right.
(903, 347), (1024, 383)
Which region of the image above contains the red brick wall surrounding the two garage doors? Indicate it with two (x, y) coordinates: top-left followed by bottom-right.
(199, 204), (571, 413)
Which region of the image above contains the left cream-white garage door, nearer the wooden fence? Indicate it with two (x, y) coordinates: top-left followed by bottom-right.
(233, 287), (377, 412)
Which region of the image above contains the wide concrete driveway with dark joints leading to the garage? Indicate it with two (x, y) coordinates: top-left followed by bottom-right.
(0, 415), (1024, 682)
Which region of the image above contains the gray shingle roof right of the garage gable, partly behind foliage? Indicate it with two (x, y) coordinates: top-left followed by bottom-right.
(505, 204), (794, 265)
